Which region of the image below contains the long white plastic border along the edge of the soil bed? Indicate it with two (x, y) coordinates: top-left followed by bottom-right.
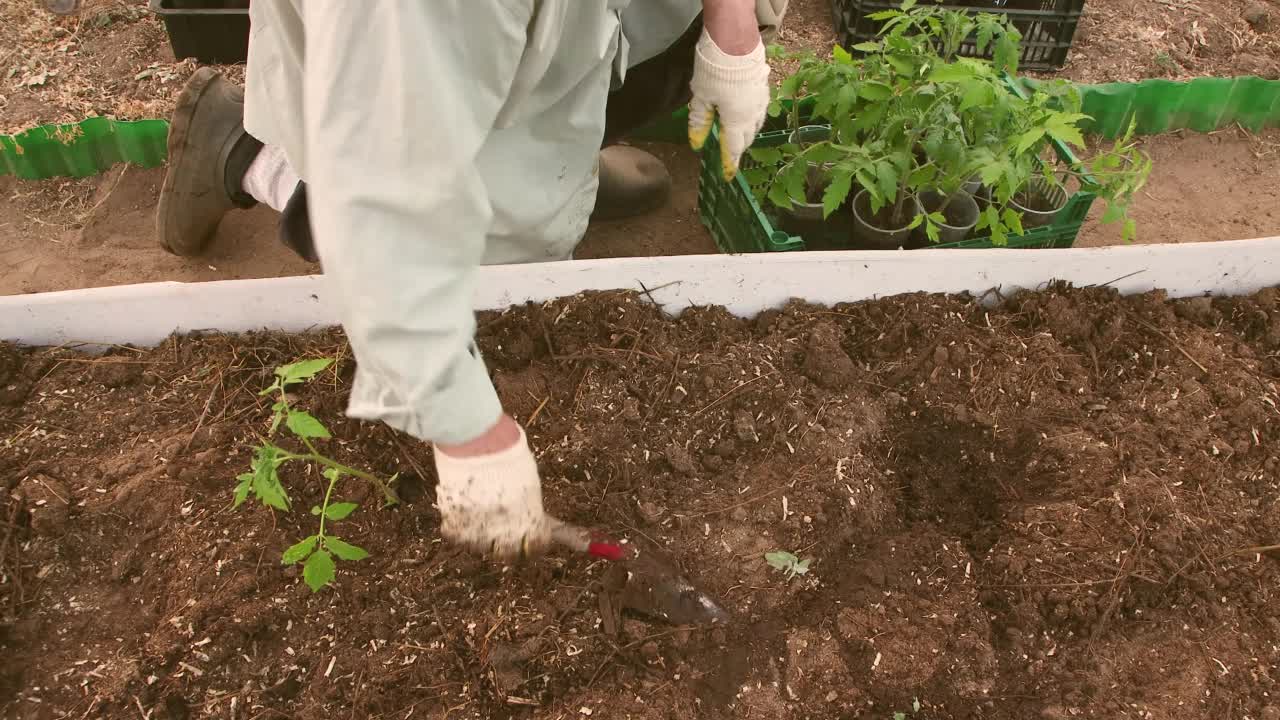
(0, 237), (1280, 346)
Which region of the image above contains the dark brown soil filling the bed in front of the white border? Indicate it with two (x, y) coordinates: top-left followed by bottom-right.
(0, 287), (1280, 720)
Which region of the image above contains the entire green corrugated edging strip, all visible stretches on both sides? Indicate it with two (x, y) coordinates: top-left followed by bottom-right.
(0, 77), (1280, 179)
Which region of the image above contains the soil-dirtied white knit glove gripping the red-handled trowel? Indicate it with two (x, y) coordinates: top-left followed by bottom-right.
(435, 428), (552, 560)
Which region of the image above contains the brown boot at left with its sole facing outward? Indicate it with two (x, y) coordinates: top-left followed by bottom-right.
(156, 68), (262, 256)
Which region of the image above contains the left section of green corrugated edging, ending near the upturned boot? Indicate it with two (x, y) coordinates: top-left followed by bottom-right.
(0, 118), (169, 179)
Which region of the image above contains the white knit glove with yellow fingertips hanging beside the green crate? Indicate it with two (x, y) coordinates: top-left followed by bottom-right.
(689, 29), (769, 181)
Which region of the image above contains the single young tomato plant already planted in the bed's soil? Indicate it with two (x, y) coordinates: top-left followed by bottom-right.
(234, 357), (397, 592)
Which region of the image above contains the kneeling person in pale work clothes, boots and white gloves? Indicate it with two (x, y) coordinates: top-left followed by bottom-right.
(157, 0), (787, 557)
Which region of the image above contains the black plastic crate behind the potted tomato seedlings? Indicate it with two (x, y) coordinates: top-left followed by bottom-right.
(831, 0), (1084, 70)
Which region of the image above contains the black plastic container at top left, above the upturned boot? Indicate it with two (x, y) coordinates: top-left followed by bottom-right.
(151, 0), (248, 65)
